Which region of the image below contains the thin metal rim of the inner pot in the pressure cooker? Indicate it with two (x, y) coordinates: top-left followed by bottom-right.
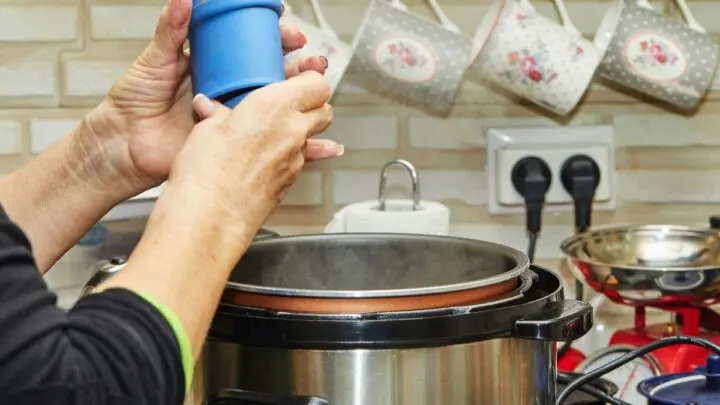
(226, 233), (530, 299)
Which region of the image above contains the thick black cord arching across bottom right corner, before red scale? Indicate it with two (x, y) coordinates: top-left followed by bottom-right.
(555, 336), (720, 405)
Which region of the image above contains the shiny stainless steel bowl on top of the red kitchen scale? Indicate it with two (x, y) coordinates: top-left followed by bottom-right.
(560, 225), (720, 305)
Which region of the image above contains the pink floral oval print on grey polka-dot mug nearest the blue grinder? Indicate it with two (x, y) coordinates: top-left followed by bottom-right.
(375, 38), (437, 83)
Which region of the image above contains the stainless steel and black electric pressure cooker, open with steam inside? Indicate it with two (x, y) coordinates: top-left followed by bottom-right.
(83, 234), (592, 405)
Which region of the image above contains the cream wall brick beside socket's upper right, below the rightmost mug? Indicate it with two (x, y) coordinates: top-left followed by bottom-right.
(613, 114), (720, 147)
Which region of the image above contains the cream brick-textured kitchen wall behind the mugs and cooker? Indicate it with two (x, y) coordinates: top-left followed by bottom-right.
(0, 0), (720, 296)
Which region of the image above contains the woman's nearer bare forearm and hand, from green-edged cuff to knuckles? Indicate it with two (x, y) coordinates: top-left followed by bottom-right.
(101, 72), (332, 358)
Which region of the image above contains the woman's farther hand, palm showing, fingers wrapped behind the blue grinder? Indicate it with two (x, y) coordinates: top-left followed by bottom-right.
(88, 0), (342, 193)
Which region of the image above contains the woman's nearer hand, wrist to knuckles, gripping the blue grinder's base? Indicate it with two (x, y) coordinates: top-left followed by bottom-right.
(169, 72), (340, 232)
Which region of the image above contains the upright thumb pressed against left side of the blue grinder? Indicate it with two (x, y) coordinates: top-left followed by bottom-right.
(148, 0), (192, 66)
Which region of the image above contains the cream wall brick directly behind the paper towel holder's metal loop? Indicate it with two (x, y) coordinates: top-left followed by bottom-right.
(333, 170), (487, 204)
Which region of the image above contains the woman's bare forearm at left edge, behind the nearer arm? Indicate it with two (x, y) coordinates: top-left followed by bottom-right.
(0, 110), (142, 273)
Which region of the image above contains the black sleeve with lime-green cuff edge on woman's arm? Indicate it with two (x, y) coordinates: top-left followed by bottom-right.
(0, 207), (185, 405)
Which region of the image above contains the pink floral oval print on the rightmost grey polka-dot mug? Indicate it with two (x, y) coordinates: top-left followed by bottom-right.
(625, 33), (688, 83)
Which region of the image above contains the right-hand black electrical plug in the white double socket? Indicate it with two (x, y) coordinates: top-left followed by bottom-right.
(560, 155), (600, 232)
